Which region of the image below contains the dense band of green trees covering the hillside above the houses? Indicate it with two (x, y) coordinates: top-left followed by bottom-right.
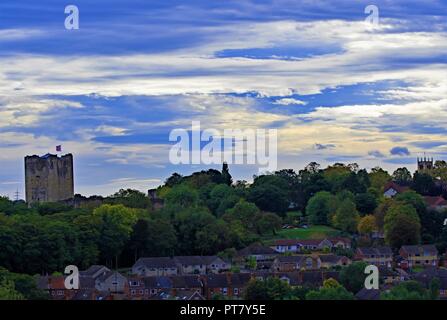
(0, 163), (447, 274)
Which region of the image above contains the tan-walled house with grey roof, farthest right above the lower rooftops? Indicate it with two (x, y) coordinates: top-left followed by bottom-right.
(399, 245), (439, 269)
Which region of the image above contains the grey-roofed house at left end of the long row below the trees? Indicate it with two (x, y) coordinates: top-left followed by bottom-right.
(132, 257), (179, 277)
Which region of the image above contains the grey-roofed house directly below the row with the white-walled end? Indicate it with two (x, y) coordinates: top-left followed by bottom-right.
(271, 255), (321, 272)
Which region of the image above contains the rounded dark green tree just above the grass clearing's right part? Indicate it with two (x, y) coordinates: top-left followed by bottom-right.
(306, 191), (337, 225)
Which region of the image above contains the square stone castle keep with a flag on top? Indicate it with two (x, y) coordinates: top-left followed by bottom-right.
(25, 154), (74, 205)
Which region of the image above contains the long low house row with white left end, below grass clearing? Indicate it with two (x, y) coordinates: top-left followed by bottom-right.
(271, 237), (351, 253)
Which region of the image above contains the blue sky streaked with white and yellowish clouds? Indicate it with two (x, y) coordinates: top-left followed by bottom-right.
(0, 0), (447, 197)
